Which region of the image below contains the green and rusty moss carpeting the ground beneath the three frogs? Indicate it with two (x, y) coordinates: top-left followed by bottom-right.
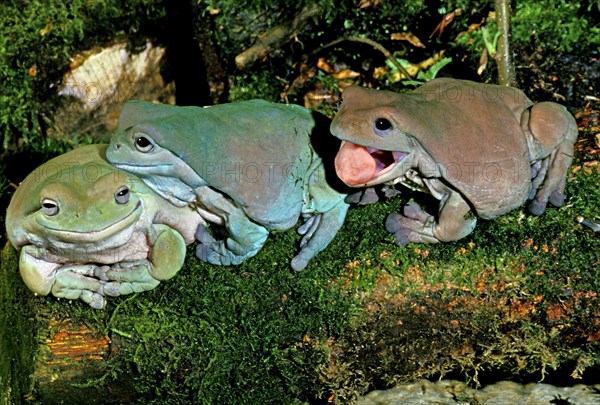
(0, 124), (600, 403)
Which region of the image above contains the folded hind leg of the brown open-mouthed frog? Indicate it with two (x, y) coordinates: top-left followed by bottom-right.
(524, 102), (577, 215)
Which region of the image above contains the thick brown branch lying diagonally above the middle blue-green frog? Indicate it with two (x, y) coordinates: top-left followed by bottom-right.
(235, 4), (321, 70)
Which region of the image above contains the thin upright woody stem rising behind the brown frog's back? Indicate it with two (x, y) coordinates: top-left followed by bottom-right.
(495, 0), (516, 86)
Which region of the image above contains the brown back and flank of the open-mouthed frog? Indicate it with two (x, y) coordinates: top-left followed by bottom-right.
(401, 79), (532, 218)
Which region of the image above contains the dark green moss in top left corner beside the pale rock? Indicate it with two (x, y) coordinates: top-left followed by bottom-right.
(0, 0), (165, 149)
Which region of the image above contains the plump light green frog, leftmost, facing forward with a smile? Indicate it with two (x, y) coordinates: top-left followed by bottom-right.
(6, 145), (204, 309)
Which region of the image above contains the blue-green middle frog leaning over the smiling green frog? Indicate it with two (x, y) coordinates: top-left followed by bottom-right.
(107, 100), (348, 270)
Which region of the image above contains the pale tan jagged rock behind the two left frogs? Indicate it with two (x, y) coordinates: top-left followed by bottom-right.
(47, 41), (175, 140)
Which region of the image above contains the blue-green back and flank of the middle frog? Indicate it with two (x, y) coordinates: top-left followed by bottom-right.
(126, 100), (314, 229)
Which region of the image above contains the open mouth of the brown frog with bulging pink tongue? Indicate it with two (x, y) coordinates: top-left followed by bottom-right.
(335, 141), (410, 187)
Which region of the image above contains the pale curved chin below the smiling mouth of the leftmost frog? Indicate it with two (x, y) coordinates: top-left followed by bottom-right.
(37, 200), (143, 244)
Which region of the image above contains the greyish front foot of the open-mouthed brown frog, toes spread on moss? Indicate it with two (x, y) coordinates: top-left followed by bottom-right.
(385, 201), (439, 246)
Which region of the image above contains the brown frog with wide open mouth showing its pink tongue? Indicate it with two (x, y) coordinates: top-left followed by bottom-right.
(331, 78), (577, 246)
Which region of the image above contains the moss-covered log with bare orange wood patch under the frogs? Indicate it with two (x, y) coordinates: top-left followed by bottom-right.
(2, 196), (600, 404)
